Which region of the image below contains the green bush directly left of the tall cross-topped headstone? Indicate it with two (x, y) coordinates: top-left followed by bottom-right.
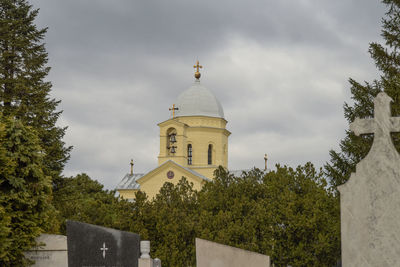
(264, 163), (340, 266)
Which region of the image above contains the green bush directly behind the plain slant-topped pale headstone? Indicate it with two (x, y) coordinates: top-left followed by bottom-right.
(198, 168), (273, 255)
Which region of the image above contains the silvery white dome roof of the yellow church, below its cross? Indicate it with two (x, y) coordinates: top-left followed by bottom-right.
(175, 81), (224, 118)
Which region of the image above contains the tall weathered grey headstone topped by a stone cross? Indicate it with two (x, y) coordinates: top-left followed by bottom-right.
(339, 92), (400, 267)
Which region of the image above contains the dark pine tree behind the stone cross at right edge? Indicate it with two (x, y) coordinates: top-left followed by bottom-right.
(325, 0), (400, 187)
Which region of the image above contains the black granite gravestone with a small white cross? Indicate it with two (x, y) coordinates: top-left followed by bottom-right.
(67, 221), (140, 267)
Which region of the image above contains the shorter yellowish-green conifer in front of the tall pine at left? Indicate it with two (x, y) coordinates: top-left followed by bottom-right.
(0, 119), (54, 266)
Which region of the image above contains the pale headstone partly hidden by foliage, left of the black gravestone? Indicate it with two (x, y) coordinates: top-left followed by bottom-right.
(24, 234), (68, 267)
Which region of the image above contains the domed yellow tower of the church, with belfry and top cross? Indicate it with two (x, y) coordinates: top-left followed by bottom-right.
(158, 61), (231, 179)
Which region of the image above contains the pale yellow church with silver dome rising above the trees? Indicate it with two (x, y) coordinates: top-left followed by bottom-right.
(116, 61), (231, 200)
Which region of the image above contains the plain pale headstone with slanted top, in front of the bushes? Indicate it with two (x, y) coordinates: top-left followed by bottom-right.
(196, 238), (270, 267)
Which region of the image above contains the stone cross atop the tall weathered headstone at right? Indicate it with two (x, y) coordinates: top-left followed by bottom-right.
(350, 92), (400, 142)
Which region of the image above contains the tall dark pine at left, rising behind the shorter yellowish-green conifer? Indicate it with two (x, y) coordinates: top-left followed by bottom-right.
(0, 0), (71, 184)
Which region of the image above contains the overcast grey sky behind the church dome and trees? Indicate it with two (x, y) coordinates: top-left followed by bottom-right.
(31, 0), (385, 189)
